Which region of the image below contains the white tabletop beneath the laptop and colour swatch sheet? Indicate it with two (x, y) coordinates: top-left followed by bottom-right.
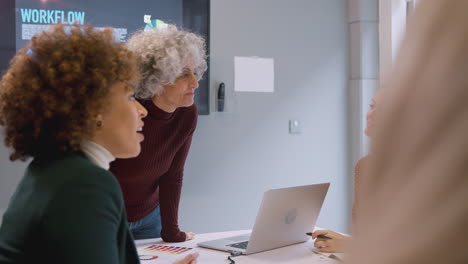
(135, 230), (337, 264)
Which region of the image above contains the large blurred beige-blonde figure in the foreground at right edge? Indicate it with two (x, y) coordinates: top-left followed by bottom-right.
(348, 0), (468, 264)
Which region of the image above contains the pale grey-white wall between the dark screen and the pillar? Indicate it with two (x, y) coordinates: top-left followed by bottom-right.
(180, 0), (352, 232)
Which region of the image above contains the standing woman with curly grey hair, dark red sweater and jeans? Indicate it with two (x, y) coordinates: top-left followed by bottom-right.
(111, 25), (207, 242)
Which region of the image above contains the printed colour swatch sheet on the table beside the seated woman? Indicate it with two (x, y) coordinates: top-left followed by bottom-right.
(137, 244), (194, 264)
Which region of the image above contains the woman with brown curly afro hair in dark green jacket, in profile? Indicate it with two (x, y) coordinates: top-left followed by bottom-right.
(0, 23), (196, 264)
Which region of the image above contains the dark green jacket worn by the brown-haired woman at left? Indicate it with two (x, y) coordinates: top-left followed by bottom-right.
(0, 153), (139, 264)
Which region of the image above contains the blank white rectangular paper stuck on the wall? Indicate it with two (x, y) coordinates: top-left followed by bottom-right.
(234, 57), (275, 93)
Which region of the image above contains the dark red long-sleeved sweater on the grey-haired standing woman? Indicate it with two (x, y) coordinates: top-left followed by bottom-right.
(110, 101), (198, 242)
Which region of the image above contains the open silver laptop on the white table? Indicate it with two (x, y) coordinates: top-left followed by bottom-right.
(198, 183), (330, 255)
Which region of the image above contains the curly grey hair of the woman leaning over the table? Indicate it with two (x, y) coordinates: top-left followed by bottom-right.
(127, 25), (207, 99)
